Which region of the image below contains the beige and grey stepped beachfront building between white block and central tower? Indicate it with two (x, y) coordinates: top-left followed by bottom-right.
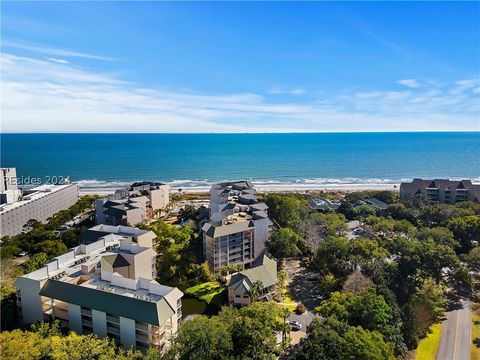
(95, 181), (170, 225)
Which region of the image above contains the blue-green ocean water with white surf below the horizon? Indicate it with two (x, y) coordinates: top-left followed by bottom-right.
(0, 132), (480, 193)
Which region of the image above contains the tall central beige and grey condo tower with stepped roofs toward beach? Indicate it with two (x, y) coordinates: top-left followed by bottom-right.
(202, 181), (272, 272)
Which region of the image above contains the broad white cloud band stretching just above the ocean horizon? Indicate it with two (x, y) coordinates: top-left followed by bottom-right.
(1, 53), (479, 132)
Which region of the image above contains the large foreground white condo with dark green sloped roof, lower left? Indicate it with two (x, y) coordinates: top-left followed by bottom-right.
(15, 227), (183, 350)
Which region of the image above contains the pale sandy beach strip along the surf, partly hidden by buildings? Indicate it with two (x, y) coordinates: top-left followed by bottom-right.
(79, 183), (400, 196)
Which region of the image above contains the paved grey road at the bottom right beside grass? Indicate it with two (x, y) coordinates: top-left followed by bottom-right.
(436, 300), (472, 360)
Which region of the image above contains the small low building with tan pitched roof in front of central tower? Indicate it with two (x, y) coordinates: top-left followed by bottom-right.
(228, 253), (277, 306)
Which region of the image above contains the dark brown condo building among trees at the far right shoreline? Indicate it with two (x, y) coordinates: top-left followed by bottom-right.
(400, 179), (480, 204)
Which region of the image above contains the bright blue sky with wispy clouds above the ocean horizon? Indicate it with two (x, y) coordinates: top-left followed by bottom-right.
(1, 2), (480, 132)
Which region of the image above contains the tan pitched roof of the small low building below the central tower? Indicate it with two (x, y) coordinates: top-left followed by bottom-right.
(228, 253), (277, 294)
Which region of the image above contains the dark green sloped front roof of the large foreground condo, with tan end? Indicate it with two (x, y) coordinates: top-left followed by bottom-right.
(40, 279), (174, 326)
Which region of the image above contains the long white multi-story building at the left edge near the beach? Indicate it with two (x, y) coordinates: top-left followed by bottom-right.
(0, 183), (78, 236)
